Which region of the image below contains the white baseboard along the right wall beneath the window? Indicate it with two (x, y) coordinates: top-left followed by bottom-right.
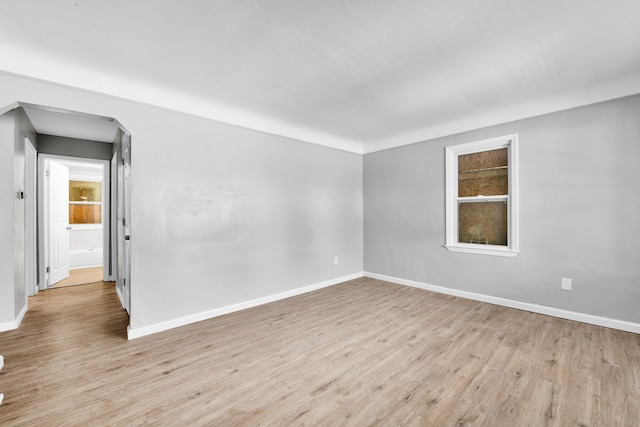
(364, 272), (640, 334)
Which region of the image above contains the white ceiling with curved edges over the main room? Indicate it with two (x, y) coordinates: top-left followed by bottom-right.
(0, 0), (640, 153)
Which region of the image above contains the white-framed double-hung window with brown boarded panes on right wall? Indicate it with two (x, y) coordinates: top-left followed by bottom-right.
(445, 135), (518, 256)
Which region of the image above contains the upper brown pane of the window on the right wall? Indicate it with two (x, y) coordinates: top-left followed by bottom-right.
(458, 148), (509, 197)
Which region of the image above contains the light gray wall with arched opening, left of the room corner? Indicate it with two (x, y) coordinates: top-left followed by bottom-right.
(0, 74), (363, 329)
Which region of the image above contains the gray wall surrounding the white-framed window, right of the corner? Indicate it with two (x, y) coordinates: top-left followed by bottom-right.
(364, 96), (640, 323)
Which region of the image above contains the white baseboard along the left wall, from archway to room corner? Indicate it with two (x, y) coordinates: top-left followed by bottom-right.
(127, 272), (363, 340)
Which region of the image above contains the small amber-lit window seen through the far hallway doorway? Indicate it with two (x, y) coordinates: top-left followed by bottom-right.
(69, 180), (102, 224)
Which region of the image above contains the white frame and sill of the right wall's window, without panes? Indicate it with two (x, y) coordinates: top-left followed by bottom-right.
(445, 134), (519, 257)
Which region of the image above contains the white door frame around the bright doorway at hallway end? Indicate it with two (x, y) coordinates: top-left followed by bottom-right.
(38, 153), (114, 290)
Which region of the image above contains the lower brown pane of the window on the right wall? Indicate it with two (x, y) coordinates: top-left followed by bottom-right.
(458, 202), (507, 246)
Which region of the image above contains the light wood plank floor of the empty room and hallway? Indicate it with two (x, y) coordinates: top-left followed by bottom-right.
(0, 278), (640, 427)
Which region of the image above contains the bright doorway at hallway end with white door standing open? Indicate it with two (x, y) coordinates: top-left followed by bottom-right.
(39, 154), (113, 289)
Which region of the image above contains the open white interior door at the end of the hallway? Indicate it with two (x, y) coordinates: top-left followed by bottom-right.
(47, 161), (69, 286)
